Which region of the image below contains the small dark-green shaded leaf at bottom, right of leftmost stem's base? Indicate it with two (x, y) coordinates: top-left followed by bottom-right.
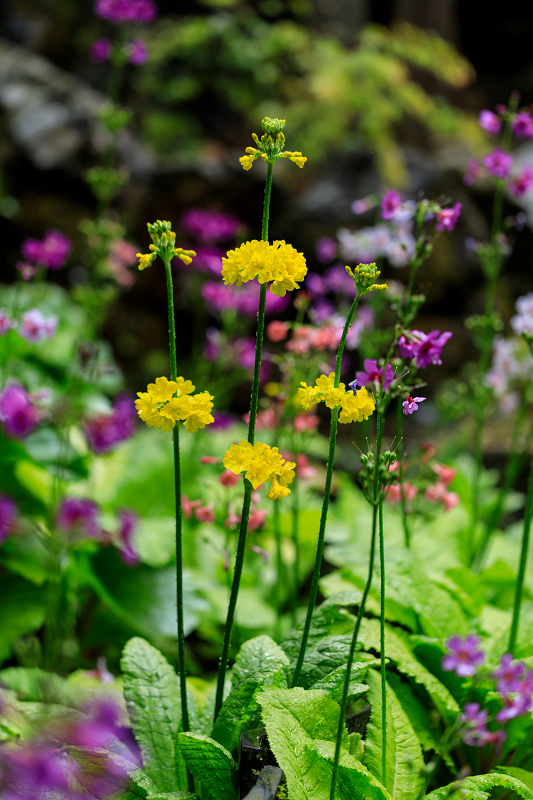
(178, 732), (237, 800)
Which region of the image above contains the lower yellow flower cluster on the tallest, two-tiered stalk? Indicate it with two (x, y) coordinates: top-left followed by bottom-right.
(222, 439), (296, 500)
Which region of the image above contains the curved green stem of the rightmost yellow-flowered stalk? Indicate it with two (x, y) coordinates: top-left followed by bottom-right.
(292, 294), (359, 686)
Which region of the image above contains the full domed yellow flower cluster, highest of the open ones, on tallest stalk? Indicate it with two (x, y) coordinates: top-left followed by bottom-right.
(222, 239), (307, 297)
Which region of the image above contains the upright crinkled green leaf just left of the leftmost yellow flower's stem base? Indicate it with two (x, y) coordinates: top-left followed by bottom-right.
(121, 637), (187, 792)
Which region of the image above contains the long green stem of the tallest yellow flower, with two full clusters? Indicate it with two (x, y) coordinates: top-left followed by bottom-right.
(214, 158), (273, 719)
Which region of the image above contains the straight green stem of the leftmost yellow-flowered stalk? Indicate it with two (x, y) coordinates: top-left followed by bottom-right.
(164, 259), (194, 752)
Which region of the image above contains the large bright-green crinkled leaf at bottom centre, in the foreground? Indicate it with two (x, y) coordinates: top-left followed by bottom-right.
(257, 687), (349, 800)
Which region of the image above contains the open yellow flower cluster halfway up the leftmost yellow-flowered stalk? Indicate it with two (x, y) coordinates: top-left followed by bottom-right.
(135, 378), (215, 433)
